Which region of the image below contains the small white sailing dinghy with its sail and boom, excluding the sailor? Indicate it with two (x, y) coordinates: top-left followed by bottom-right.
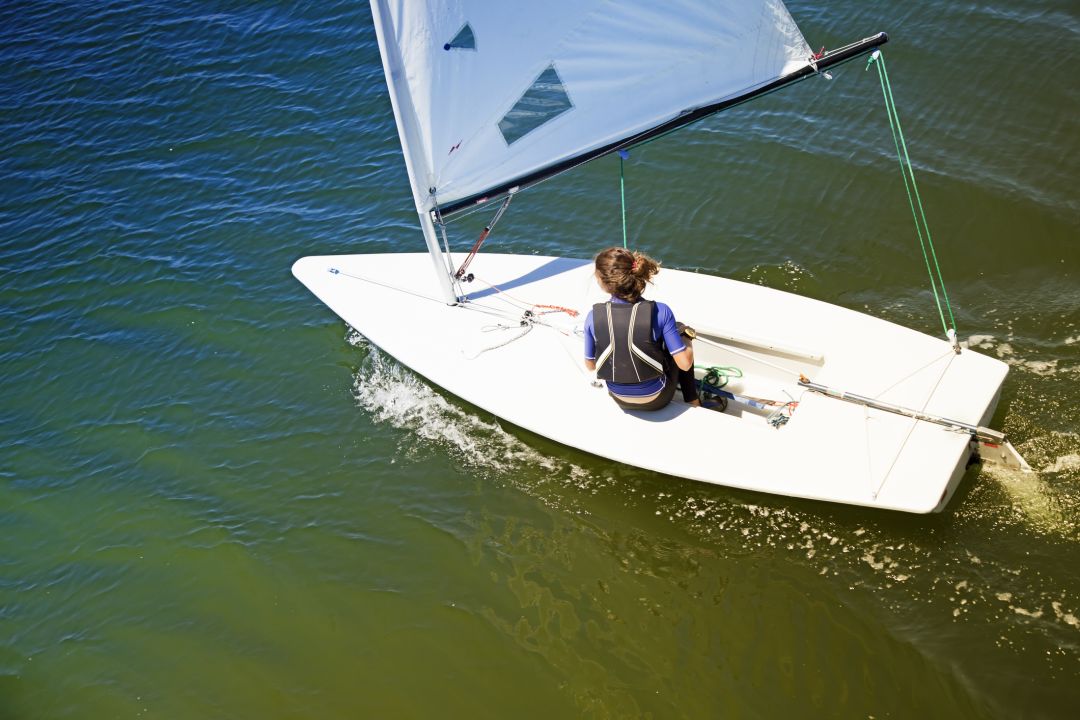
(293, 0), (1026, 513)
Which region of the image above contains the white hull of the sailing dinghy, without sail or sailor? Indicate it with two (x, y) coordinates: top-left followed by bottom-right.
(293, 254), (1008, 513)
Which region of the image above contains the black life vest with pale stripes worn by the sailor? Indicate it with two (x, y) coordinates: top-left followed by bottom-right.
(593, 300), (667, 384)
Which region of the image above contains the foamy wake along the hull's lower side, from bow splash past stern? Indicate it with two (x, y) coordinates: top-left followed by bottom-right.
(349, 332), (1080, 648)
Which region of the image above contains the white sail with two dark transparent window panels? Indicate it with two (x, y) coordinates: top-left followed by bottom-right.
(372, 0), (811, 212)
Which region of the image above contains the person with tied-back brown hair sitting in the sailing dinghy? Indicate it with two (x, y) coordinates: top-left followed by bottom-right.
(585, 247), (701, 410)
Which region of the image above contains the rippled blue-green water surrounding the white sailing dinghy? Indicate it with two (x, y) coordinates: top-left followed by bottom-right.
(0, 0), (1080, 718)
